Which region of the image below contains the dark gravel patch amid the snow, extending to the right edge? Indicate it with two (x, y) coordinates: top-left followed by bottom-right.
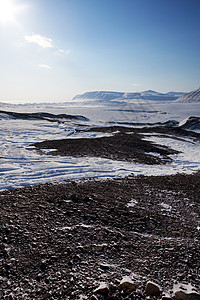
(31, 125), (200, 165)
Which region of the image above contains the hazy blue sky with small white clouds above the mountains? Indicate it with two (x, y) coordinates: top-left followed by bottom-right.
(0, 0), (200, 103)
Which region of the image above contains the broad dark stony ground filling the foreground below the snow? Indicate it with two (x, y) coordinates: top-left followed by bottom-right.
(0, 172), (200, 300)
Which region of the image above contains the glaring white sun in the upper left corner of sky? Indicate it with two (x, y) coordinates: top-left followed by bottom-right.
(0, 0), (18, 24)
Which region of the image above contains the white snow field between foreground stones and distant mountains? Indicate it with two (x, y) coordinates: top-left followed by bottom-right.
(0, 99), (200, 190)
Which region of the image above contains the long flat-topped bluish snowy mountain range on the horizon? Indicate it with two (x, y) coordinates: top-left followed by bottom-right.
(72, 90), (185, 101)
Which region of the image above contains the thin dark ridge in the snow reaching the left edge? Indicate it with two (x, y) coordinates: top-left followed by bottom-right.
(0, 110), (89, 122)
